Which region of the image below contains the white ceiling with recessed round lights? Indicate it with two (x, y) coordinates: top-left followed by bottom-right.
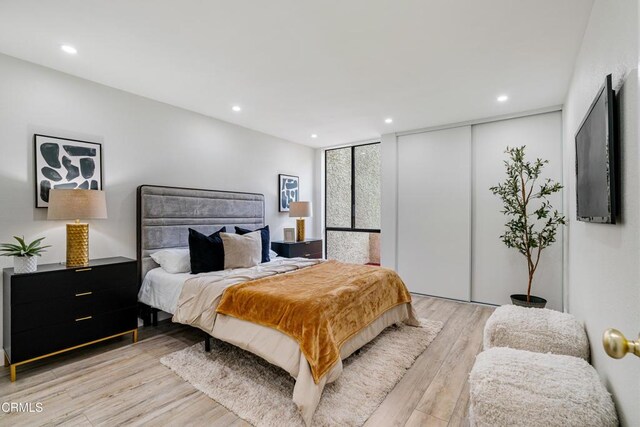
(0, 0), (593, 146)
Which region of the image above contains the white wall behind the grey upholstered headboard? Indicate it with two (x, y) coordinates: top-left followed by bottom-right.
(0, 55), (320, 348)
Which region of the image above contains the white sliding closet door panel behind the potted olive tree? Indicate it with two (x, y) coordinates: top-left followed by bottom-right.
(471, 112), (567, 310)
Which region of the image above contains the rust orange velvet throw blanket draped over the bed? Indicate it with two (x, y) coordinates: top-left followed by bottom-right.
(217, 261), (411, 383)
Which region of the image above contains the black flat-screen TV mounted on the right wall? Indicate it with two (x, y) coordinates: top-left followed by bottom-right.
(576, 75), (617, 224)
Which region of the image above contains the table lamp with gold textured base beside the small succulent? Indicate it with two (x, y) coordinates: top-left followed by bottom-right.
(47, 189), (107, 267)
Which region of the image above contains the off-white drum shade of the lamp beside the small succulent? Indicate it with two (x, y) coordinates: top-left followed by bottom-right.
(47, 189), (107, 219)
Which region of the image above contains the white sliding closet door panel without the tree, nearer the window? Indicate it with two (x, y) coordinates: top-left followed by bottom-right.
(397, 126), (471, 301)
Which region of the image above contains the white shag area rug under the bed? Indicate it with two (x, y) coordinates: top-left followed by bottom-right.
(160, 319), (442, 427)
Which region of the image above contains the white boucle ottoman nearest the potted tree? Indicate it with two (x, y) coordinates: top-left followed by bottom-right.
(484, 305), (589, 361)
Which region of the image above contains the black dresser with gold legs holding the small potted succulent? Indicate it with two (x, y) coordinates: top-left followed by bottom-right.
(3, 257), (138, 381)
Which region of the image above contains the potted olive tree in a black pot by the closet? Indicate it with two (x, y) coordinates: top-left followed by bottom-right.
(490, 146), (565, 308)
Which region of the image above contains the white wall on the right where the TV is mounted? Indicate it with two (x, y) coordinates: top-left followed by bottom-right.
(563, 0), (640, 426)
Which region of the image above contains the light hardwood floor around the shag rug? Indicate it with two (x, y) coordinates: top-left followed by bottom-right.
(0, 296), (493, 427)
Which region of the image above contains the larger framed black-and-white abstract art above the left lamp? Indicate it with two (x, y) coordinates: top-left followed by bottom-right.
(33, 135), (102, 208)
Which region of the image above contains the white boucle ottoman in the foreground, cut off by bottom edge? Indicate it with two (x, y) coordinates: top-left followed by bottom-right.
(469, 347), (618, 427)
